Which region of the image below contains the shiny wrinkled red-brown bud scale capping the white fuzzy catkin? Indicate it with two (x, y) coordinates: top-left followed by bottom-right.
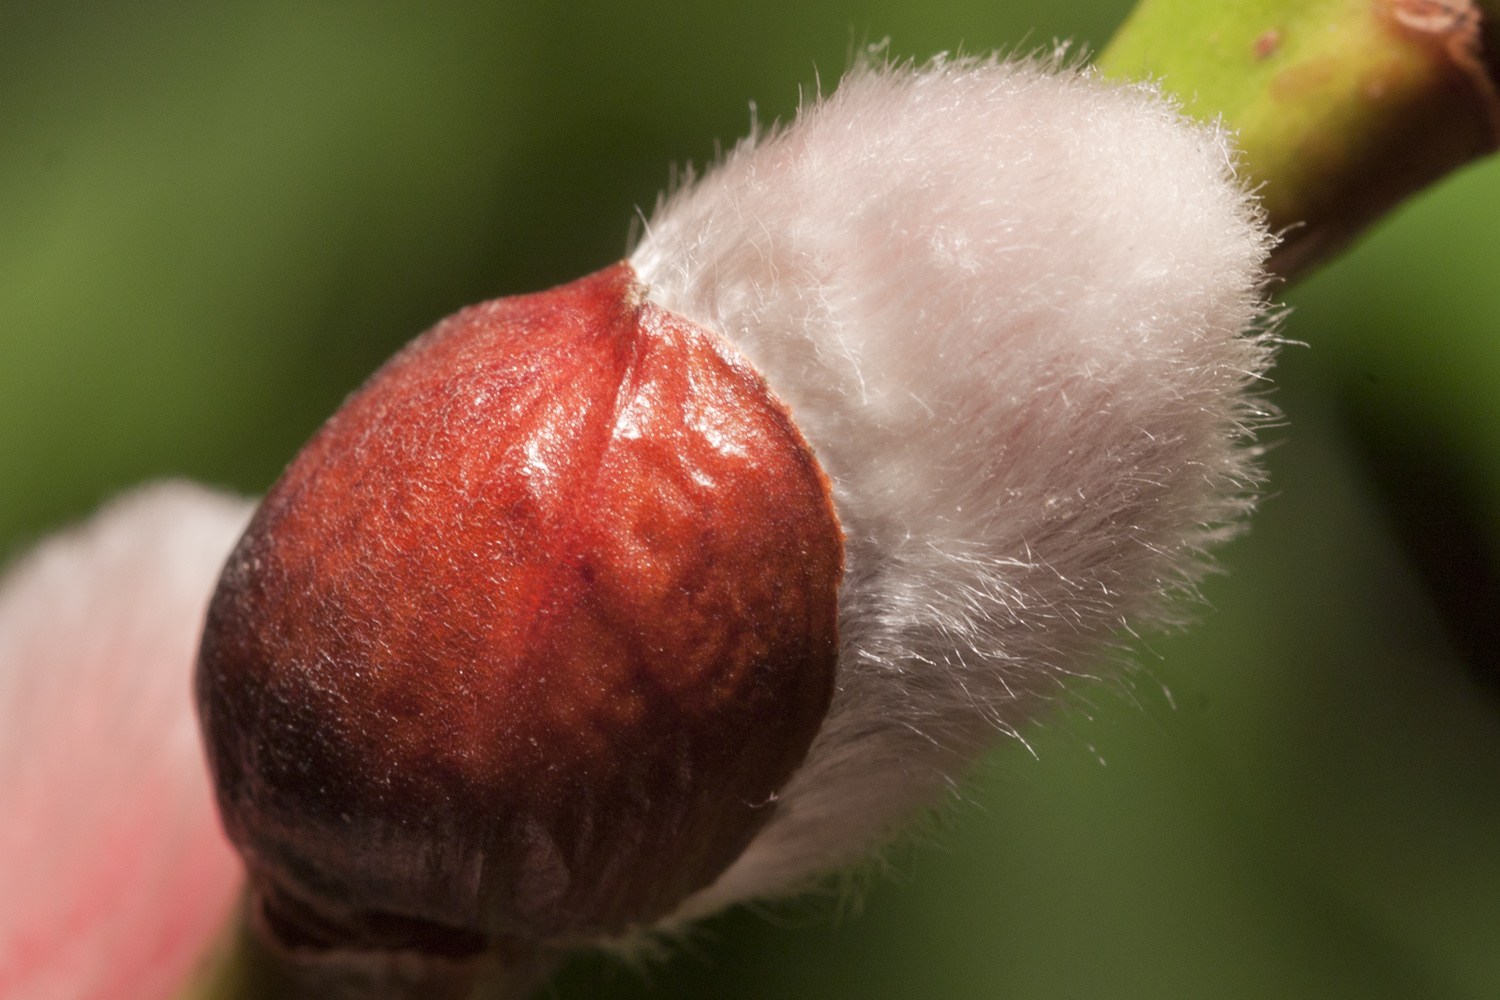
(197, 264), (843, 954)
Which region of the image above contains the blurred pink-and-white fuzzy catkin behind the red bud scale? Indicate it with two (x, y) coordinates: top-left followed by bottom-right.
(0, 483), (252, 1000)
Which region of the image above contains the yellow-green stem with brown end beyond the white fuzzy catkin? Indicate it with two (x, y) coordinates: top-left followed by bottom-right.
(1100, 0), (1500, 277)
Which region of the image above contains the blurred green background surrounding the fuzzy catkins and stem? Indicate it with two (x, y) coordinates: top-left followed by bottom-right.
(0, 0), (1500, 1000)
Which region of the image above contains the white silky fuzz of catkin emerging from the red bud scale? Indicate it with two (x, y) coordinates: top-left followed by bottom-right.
(630, 50), (1274, 921)
